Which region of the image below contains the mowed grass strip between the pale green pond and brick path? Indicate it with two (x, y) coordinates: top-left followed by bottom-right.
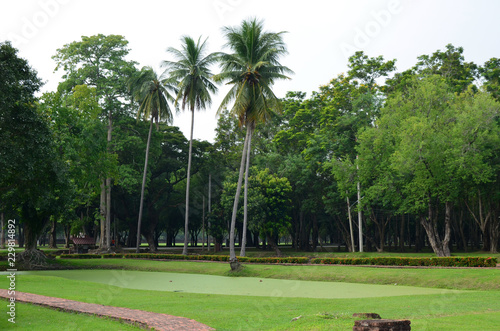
(0, 275), (500, 330)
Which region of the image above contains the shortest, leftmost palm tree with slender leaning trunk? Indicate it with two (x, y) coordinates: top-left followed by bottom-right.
(128, 67), (175, 253)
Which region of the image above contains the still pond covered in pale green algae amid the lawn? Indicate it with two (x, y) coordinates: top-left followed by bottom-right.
(17, 270), (458, 299)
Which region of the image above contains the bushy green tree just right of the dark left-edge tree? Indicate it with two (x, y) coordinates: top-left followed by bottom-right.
(39, 85), (109, 249)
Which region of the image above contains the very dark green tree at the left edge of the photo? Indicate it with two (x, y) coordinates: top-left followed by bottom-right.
(0, 42), (69, 268)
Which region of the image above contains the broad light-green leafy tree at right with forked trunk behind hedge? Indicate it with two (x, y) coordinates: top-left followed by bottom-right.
(360, 76), (498, 256)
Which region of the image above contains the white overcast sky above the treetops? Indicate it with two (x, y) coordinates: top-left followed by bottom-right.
(0, 0), (500, 141)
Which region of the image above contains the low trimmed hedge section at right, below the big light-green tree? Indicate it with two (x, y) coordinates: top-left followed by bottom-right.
(311, 257), (497, 267)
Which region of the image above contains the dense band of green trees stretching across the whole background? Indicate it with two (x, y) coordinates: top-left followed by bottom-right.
(0, 25), (500, 263)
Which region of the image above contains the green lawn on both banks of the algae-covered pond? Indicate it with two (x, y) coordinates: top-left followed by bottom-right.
(0, 259), (500, 330)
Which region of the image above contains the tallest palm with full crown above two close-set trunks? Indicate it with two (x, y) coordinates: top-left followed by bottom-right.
(214, 19), (292, 267)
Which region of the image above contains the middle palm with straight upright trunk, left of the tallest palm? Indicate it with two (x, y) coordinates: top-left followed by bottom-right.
(163, 36), (218, 255)
